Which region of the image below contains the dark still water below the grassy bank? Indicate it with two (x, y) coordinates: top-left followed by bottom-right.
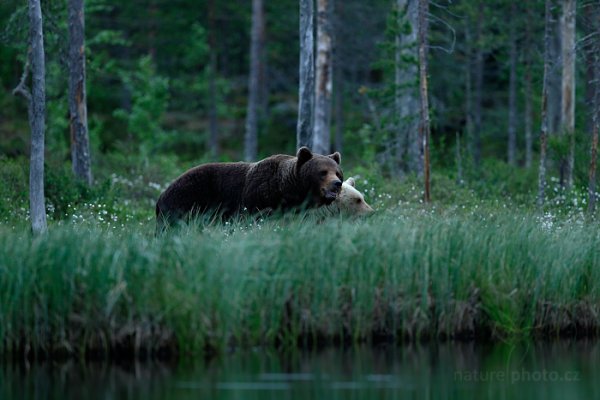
(0, 342), (600, 400)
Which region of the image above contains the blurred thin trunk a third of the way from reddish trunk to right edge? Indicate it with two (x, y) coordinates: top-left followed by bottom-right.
(473, 0), (484, 168)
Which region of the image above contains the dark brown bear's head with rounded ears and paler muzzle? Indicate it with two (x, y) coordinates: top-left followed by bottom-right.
(296, 147), (344, 206)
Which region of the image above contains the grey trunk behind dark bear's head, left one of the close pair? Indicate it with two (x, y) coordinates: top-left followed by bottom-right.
(296, 0), (315, 148)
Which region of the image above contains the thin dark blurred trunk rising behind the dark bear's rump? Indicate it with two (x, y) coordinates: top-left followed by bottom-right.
(208, 0), (219, 160)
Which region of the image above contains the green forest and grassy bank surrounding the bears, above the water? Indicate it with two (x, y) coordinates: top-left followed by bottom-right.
(0, 0), (600, 357)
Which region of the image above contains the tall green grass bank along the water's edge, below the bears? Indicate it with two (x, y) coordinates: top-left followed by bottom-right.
(0, 210), (600, 356)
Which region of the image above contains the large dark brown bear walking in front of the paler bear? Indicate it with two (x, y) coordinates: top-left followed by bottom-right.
(156, 147), (344, 230)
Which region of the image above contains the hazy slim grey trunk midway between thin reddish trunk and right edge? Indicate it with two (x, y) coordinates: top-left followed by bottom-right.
(508, 2), (517, 166)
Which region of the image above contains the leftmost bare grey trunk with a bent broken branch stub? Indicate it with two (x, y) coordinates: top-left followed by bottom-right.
(13, 0), (47, 234)
